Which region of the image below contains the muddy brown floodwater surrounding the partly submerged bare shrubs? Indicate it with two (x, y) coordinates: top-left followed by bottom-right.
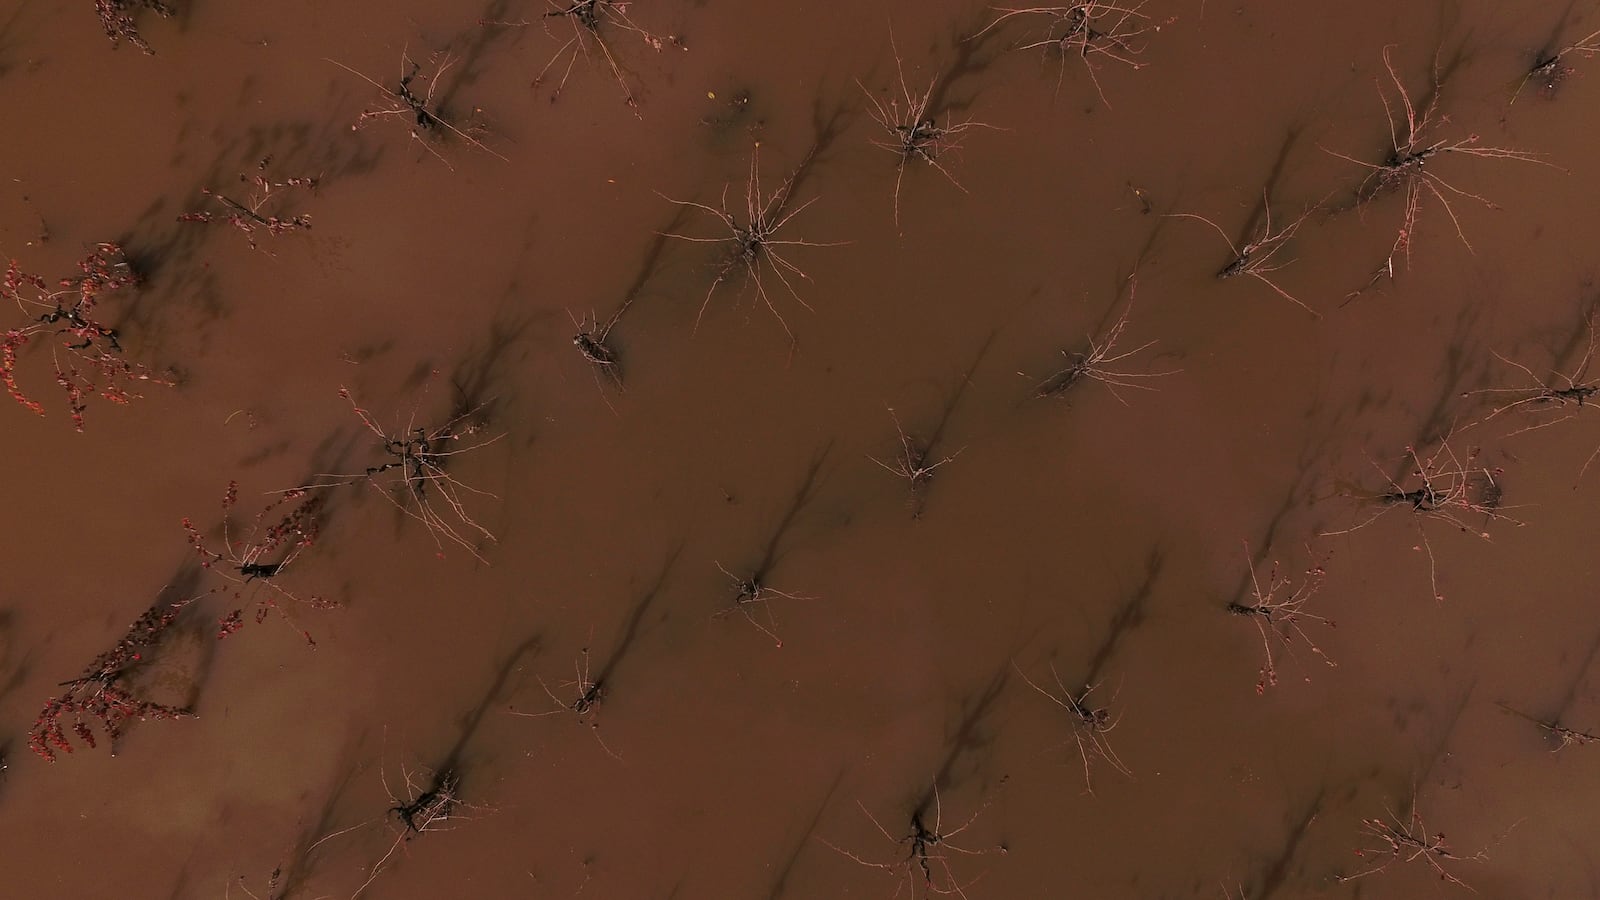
(0, 0), (1600, 900)
